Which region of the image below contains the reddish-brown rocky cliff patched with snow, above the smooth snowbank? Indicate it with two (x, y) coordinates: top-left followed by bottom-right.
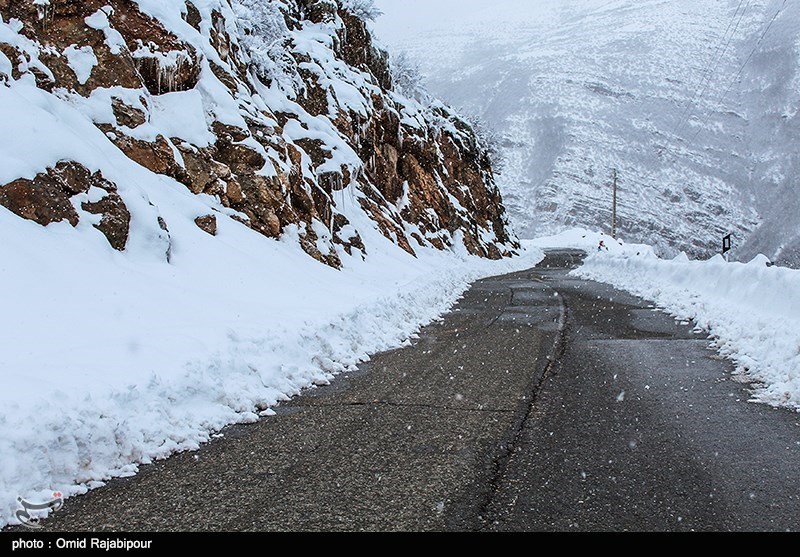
(0, 0), (519, 267)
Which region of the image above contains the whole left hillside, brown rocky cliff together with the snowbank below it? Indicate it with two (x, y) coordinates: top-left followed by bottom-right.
(0, 0), (537, 526)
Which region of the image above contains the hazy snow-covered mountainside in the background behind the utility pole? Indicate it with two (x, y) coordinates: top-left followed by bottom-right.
(375, 0), (800, 265)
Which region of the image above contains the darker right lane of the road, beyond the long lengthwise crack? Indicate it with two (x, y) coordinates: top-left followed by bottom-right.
(484, 251), (800, 532)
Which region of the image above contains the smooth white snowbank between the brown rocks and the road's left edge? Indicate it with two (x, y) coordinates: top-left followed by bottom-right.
(0, 163), (540, 525)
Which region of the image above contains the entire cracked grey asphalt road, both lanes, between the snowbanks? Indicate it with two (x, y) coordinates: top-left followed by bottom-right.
(20, 250), (800, 532)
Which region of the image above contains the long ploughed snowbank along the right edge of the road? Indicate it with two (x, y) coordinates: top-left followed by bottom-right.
(529, 230), (800, 411)
